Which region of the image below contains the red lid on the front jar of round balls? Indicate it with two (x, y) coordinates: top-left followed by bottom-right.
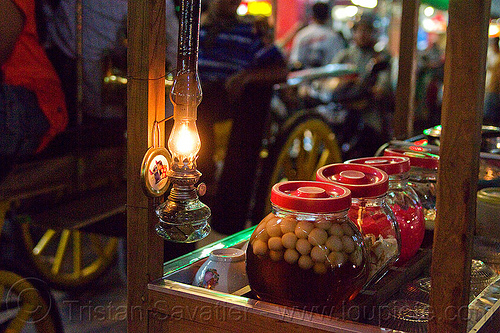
(271, 181), (351, 213)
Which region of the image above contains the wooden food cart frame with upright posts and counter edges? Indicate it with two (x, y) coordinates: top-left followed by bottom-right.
(127, 0), (500, 333)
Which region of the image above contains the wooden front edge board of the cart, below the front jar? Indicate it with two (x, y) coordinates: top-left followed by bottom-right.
(149, 282), (384, 333)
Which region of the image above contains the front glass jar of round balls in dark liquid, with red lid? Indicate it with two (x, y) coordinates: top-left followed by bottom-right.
(247, 181), (368, 309)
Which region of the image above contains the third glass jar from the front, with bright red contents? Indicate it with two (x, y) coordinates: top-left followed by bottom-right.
(345, 156), (425, 265)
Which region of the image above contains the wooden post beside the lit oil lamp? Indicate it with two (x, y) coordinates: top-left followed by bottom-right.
(127, 0), (166, 333)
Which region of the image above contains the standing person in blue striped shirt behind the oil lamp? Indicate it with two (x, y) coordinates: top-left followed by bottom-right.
(197, 0), (287, 234)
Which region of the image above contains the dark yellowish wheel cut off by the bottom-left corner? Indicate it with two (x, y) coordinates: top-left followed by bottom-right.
(0, 269), (63, 333)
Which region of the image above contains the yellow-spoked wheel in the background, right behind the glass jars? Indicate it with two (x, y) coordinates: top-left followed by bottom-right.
(252, 111), (342, 221)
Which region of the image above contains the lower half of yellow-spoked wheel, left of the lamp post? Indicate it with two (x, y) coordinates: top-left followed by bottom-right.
(21, 223), (118, 290)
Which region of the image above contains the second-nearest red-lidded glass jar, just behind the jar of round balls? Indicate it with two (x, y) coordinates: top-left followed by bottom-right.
(316, 163), (401, 284)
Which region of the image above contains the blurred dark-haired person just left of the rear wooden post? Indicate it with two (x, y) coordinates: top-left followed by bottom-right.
(333, 14), (394, 144)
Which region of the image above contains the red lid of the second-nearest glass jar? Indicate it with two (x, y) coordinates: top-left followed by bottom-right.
(316, 163), (389, 198)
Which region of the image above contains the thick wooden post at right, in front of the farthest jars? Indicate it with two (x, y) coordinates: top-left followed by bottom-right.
(429, 0), (490, 333)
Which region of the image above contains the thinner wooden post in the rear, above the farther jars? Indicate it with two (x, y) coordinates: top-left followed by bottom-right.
(393, 1), (420, 140)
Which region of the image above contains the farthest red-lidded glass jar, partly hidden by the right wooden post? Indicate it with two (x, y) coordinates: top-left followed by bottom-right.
(384, 147), (439, 230)
